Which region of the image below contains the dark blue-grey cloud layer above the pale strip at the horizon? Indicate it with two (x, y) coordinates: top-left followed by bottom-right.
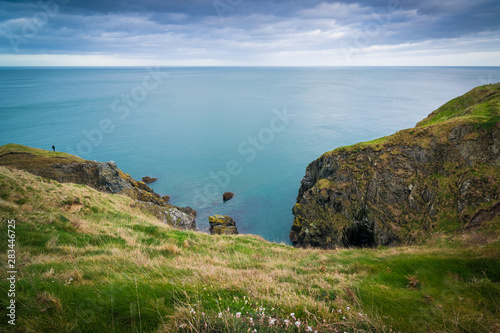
(0, 0), (500, 61)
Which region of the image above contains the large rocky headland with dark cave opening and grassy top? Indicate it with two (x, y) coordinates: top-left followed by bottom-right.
(290, 84), (500, 248)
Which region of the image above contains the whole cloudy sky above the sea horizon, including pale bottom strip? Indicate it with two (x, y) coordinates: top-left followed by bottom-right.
(0, 0), (500, 66)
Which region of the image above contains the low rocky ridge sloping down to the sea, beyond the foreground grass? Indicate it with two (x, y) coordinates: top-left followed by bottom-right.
(0, 144), (197, 230)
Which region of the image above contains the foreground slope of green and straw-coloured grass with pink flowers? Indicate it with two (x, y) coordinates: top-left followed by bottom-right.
(0, 167), (500, 332)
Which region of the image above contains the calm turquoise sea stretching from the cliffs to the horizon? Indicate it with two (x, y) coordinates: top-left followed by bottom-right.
(0, 67), (500, 242)
